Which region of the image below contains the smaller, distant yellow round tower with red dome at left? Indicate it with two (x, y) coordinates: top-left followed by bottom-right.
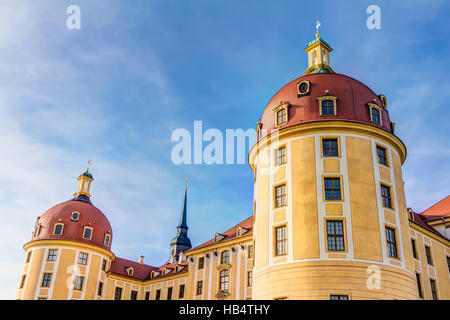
(16, 169), (114, 300)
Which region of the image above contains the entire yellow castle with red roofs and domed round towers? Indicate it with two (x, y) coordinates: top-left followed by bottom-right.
(16, 32), (450, 300)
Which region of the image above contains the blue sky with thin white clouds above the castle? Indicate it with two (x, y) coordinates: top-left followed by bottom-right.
(0, 0), (450, 299)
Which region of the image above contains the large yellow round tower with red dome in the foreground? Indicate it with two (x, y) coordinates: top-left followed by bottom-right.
(249, 33), (418, 299)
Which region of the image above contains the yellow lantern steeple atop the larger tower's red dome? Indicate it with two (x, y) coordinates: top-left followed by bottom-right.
(305, 18), (334, 74)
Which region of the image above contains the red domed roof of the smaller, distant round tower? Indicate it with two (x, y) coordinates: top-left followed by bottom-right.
(32, 199), (112, 250)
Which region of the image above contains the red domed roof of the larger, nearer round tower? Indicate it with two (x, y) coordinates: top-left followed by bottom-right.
(260, 73), (392, 136)
